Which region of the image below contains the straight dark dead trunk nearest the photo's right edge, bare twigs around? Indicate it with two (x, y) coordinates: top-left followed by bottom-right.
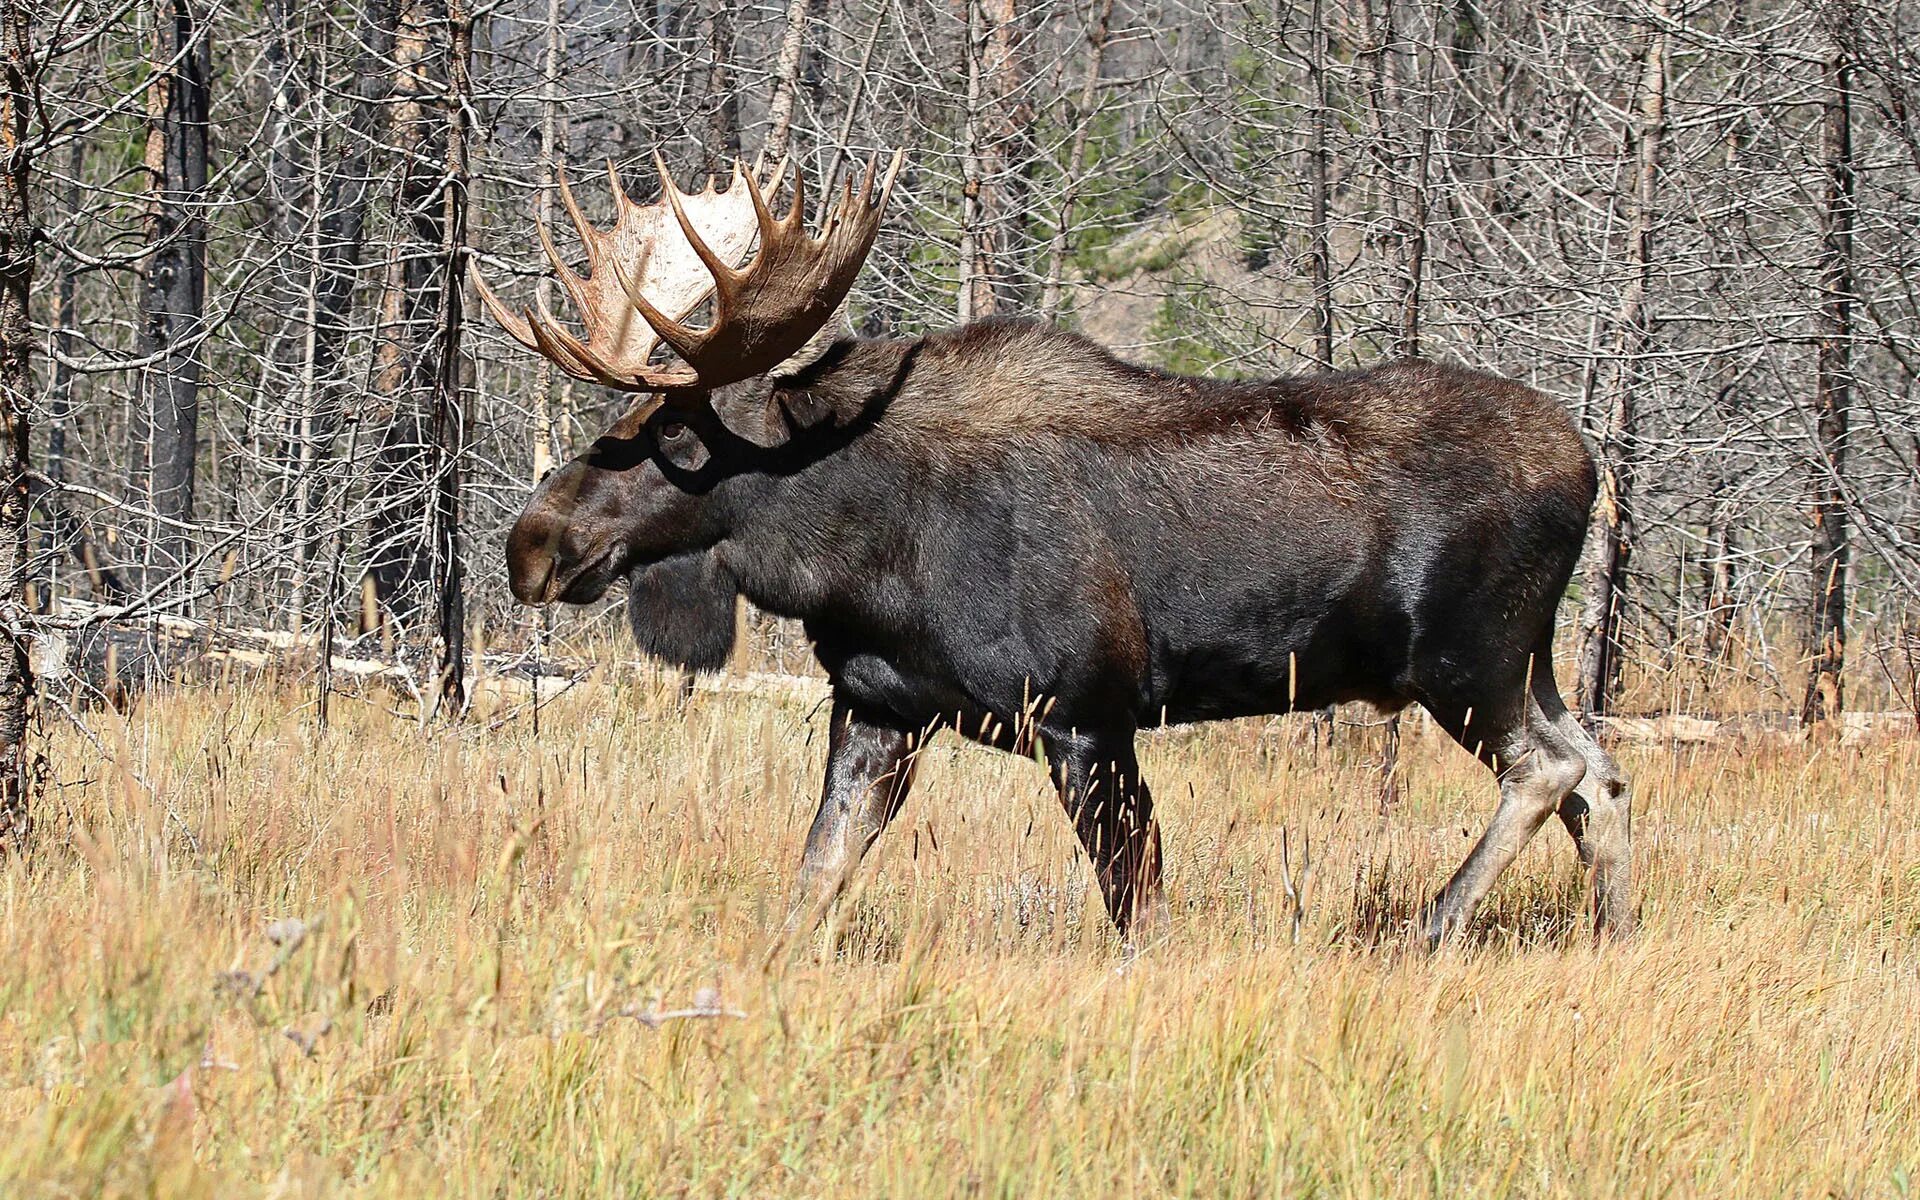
(1801, 2), (1855, 726)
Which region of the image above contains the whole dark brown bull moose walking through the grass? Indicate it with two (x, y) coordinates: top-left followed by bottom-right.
(474, 154), (1634, 945)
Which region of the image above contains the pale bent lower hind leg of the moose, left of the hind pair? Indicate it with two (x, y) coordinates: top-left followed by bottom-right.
(1427, 695), (1588, 945)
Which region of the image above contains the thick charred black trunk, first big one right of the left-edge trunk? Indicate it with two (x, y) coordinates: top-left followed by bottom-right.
(129, 0), (213, 588)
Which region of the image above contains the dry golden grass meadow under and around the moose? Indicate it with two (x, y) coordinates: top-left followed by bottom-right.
(0, 668), (1920, 1196)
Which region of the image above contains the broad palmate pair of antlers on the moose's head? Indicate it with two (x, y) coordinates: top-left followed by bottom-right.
(474, 154), (902, 392)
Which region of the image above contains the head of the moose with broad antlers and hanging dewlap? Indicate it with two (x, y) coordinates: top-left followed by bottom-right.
(474, 154), (902, 668)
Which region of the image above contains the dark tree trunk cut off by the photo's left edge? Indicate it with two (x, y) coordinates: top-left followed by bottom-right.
(0, 0), (38, 849)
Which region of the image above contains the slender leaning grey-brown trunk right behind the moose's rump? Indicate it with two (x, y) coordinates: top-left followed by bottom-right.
(1576, 0), (1667, 720)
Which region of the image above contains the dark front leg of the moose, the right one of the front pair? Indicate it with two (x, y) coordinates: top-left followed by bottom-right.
(1046, 732), (1165, 939)
